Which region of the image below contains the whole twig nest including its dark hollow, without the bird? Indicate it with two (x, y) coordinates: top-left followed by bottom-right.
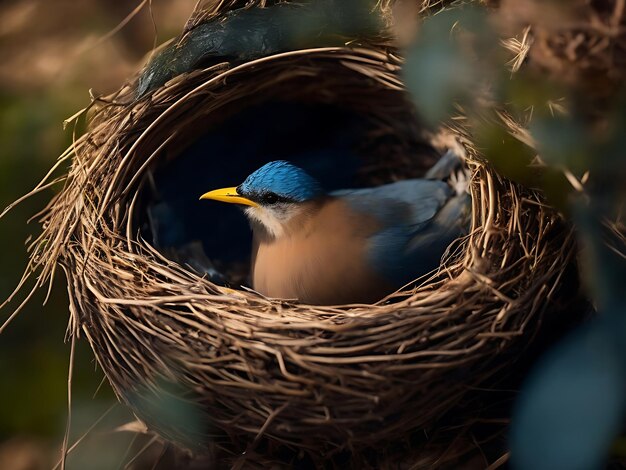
(7, 2), (608, 468)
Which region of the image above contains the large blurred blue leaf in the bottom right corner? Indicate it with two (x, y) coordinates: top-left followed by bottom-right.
(510, 320), (626, 470)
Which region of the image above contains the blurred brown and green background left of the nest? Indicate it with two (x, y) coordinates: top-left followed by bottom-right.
(0, 0), (195, 470)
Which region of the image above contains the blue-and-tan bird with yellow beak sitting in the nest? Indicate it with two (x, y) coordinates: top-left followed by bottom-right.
(200, 160), (470, 305)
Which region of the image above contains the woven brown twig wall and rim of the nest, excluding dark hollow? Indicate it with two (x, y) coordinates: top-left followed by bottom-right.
(12, 1), (574, 468)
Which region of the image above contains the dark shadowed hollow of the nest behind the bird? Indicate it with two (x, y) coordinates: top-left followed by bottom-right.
(135, 60), (447, 287)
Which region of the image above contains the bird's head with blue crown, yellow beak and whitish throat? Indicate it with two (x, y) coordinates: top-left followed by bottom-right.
(200, 160), (325, 238)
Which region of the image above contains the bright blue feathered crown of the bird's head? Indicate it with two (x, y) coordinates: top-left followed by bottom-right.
(237, 160), (324, 204)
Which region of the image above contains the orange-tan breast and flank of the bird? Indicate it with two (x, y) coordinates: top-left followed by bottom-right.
(252, 200), (392, 305)
